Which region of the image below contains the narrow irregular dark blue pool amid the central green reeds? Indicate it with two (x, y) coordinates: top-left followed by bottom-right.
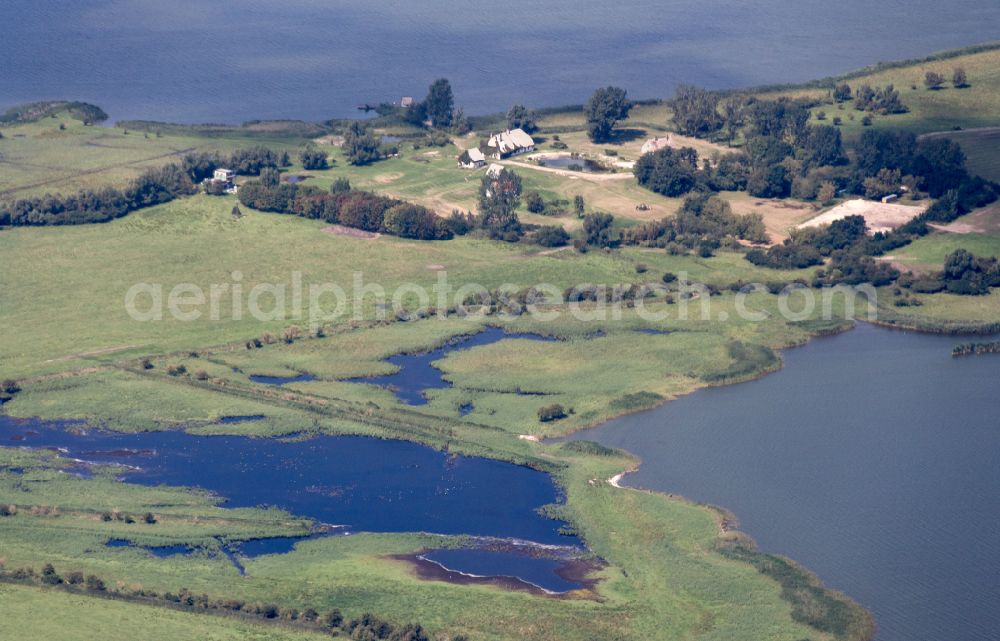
(348, 327), (556, 402)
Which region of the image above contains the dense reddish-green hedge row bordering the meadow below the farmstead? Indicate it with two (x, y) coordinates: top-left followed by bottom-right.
(239, 178), (453, 240)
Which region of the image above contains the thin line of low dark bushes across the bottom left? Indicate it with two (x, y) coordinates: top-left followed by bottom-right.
(0, 563), (438, 641)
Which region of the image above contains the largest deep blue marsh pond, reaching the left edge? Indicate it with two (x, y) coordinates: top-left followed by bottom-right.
(0, 416), (578, 545)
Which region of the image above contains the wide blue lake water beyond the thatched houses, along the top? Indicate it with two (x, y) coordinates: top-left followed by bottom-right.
(0, 0), (1000, 122)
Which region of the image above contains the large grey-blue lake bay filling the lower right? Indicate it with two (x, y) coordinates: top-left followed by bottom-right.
(577, 325), (1000, 641)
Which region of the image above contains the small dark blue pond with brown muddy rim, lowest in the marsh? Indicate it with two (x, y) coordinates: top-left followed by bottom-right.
(421, 549), (583, 592)
